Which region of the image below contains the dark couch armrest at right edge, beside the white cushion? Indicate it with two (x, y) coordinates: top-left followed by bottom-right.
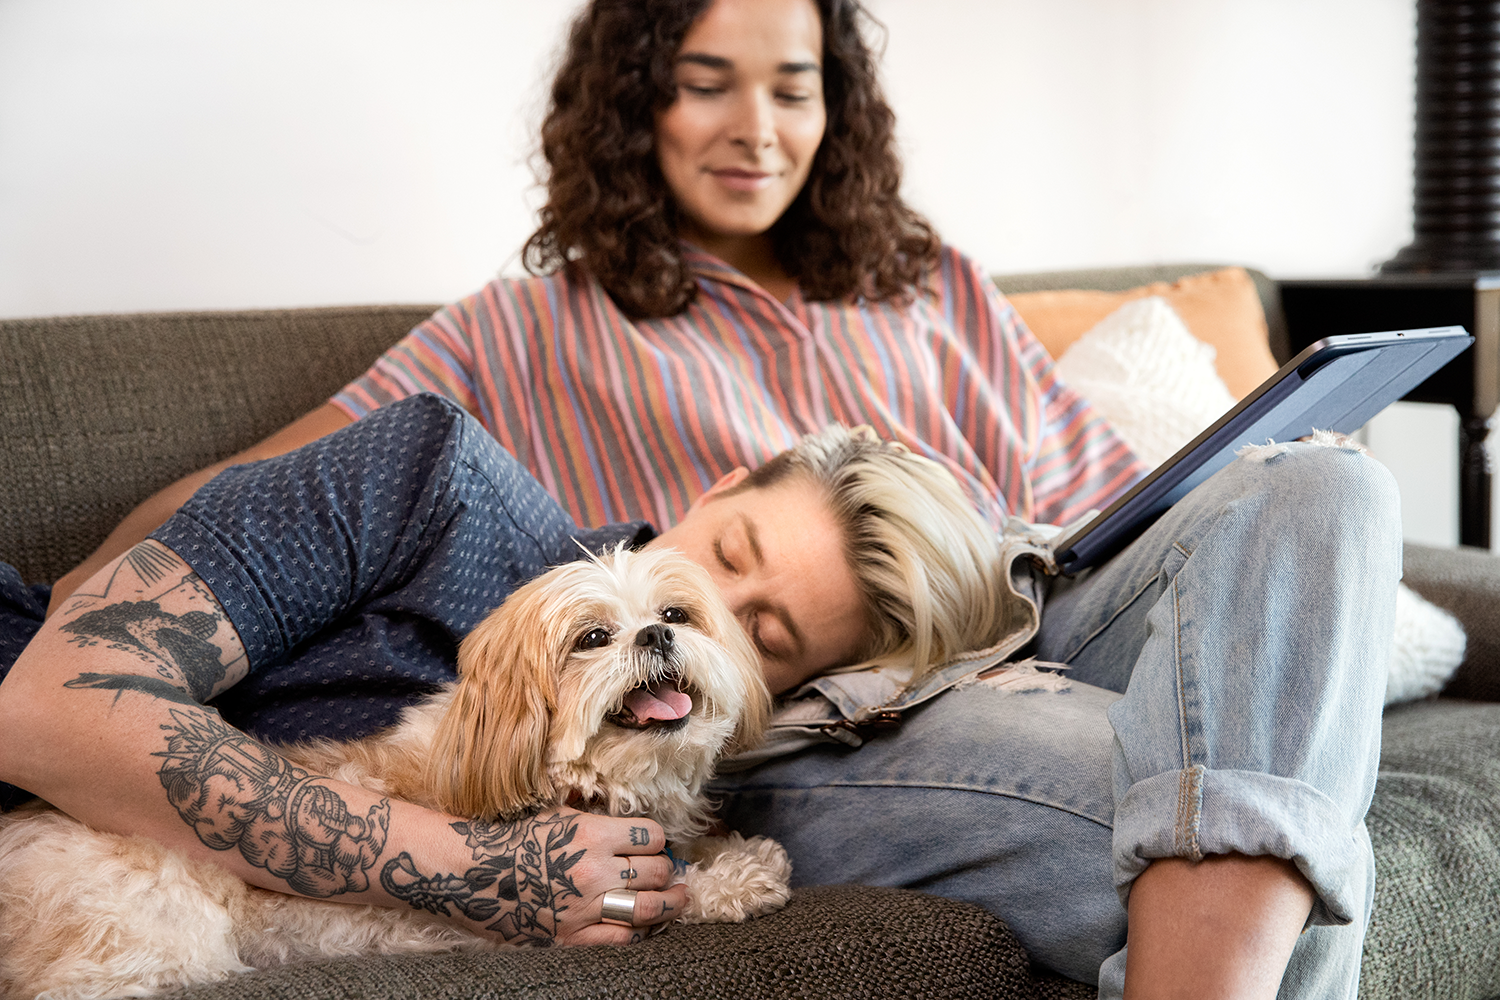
(1406, 543), (1500, 702)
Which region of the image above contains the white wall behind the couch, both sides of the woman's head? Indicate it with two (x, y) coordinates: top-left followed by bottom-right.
(0, 0), (1464, 548)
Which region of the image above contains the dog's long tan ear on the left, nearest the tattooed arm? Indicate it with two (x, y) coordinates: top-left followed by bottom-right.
(428, 585), (560, 819)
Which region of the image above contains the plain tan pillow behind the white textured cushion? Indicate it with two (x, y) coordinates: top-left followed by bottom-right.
(1007, 267), (1277, 399)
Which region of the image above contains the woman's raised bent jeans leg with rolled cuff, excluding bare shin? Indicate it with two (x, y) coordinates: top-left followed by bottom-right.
(1038, 444), (1401, 997)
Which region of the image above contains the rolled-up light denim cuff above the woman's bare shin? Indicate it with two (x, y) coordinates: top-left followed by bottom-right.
(1115, 766), (1370, 927)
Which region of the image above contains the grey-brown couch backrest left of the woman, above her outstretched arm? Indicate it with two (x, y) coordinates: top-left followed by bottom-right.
(0, 306), (434, 582)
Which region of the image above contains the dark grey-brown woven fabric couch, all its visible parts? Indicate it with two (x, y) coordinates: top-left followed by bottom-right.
(0, 265), (1500, 1000)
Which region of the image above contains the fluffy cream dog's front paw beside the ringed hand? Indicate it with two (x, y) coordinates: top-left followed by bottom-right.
(683, 834), (792, 924)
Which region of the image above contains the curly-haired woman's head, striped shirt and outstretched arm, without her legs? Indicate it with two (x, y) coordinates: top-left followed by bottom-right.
(54, 0), (1143, 563)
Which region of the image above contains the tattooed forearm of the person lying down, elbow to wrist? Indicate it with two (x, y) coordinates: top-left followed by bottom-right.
(8, 659), (600, 942)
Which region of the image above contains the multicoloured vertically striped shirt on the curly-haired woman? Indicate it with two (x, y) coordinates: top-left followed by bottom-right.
(333, 247), (1146, 526)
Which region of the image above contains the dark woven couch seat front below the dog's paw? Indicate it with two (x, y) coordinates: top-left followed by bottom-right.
(155, 886), (1094, 1000)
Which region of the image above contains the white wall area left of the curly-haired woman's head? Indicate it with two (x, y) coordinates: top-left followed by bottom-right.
(0, 0), (570, 316)
